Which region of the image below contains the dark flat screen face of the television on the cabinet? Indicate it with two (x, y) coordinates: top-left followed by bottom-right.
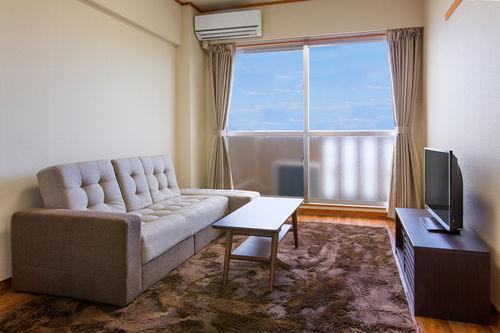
(425, 149), (450, 225)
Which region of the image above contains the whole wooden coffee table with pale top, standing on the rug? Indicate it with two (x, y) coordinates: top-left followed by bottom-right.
(212, 197), (304, 292)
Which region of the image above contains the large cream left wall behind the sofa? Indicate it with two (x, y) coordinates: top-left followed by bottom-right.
(0, 0), (180, 280)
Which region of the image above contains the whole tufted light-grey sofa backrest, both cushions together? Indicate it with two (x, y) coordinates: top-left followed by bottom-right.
(37, 155), (180, 212)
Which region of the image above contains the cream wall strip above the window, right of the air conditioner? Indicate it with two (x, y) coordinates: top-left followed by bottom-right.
(211, 0), (424, 41)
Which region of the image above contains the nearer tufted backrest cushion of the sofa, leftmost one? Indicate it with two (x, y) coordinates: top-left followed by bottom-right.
(37, 160), (126, 212)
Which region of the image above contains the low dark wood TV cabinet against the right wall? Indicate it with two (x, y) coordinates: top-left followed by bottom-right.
(395, 208), (490, 324)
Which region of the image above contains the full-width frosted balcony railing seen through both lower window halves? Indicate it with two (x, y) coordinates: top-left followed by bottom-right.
(228, 131), (394, 206)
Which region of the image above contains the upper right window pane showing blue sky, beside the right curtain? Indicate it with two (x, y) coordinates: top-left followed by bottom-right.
(309, 41), (394, 130)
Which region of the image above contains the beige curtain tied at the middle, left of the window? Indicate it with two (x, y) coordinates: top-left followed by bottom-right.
(208, 44), (236, 189)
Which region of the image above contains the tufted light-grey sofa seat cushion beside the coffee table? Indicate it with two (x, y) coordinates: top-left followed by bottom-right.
(135, 195), (228, 265)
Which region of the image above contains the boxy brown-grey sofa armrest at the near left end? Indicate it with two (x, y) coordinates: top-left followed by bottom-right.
(11, 208), (142, 306)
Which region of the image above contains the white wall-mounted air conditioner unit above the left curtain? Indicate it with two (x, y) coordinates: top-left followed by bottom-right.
(194, 10), (262, 40)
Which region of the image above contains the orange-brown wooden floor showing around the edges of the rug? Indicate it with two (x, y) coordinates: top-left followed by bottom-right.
(0, 214), (500, 333)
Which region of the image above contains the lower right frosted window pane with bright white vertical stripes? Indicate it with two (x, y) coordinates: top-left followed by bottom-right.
(309, 136), (394, 204)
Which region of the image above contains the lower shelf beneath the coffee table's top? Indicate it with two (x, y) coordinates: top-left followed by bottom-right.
(229, 224), (292, 262)
